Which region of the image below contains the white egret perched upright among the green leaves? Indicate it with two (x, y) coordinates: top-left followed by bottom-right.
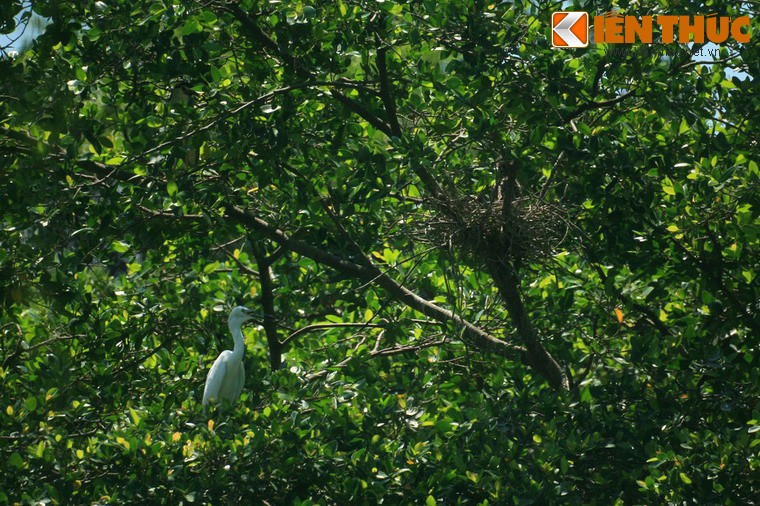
(203, 306), (255, 410)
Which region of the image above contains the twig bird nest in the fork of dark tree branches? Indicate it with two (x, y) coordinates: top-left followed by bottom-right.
(424, 192), (568, 264)
